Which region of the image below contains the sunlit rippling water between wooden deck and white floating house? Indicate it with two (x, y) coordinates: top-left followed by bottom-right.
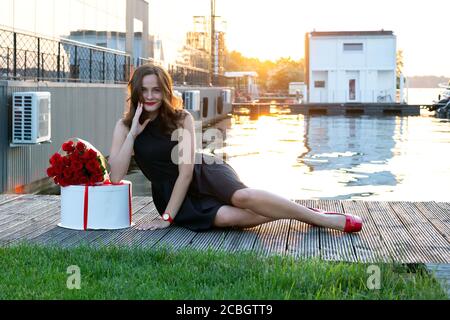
(39, 115), (450, 201)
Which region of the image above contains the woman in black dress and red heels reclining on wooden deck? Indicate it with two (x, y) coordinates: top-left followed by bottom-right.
(109, 65), (362, 232)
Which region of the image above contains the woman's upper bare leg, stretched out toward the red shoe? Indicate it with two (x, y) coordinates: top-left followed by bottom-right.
(231, 188), (345, 230)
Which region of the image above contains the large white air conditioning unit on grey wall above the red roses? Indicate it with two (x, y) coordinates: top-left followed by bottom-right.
(12, 92), (51, 144)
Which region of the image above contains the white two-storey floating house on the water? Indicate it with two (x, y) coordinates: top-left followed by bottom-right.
(305, 30), (396, 103)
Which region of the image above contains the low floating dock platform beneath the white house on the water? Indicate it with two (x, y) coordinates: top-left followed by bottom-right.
(232, 102), (429, 117)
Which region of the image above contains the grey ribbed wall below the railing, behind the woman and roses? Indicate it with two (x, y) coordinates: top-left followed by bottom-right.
(0, 81), (231, 193)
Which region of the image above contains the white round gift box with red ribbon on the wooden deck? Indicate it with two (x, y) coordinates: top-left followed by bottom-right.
(58, 180), (132, 230)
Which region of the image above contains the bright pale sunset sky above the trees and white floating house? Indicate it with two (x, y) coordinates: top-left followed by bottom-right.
(149, 0), (450, 77)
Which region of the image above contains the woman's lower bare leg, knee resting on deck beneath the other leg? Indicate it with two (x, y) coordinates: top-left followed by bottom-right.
(214, 205), (276, 228)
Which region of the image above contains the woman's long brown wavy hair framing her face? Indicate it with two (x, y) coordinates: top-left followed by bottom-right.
(123, 64), (186, 134)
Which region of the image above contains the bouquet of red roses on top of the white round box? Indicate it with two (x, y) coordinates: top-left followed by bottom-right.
(47, 138), (109, 187)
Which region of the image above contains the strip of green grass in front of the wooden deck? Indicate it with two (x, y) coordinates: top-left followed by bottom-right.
(0, 244), (447, 300)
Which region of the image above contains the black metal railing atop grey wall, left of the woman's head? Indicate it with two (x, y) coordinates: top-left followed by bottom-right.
(0, 29), (130, 83)
